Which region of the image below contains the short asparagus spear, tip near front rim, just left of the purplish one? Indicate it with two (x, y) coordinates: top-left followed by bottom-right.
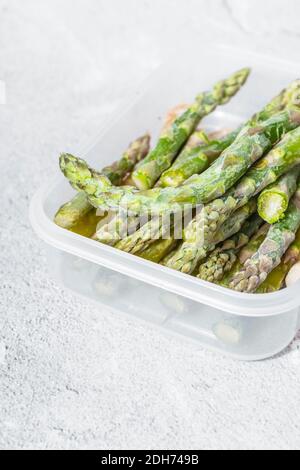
(197, 214), (263, 282)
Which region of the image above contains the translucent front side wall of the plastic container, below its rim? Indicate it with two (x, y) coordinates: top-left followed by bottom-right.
(48, 247), (298, 360)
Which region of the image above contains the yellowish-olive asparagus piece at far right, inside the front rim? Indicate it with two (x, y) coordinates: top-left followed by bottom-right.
(256, 230), (300, 294)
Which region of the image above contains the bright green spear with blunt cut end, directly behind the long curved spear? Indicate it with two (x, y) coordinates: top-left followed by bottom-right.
(159, 128), (241, 188)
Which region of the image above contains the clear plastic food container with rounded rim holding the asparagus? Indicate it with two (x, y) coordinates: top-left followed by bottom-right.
(30, 46), (300, 360)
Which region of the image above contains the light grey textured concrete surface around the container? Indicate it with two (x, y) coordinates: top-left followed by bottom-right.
(0, 0), (300, 449)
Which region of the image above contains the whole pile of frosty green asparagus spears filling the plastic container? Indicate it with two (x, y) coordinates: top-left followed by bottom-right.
(55, 68), (300, 293)
